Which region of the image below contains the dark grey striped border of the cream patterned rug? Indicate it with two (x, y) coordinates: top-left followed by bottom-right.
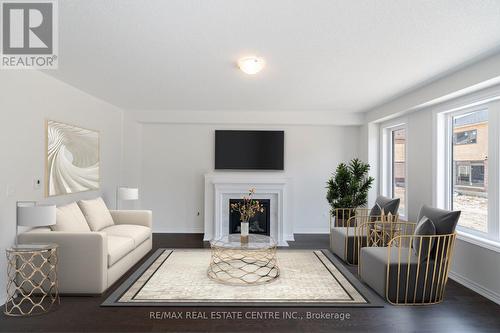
(101, 248), (385, 308)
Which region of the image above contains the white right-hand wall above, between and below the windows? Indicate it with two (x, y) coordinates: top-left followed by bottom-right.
(362, 50), (500, 302)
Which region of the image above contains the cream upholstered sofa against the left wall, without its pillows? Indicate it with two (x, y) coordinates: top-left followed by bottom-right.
(19, 198), (152, 294)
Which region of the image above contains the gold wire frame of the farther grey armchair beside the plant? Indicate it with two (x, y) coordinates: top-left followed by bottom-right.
(330, 208), (399, 266)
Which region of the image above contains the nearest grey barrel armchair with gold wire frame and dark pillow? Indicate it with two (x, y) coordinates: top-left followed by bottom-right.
(358, 206), (460, 305)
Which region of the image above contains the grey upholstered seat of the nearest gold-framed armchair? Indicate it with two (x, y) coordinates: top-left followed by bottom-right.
(359, 247), (439, 303)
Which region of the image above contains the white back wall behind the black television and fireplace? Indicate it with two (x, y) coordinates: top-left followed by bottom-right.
(141, 124), (359, 233)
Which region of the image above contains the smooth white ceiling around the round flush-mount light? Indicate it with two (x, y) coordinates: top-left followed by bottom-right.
(49, 0), (500, 112)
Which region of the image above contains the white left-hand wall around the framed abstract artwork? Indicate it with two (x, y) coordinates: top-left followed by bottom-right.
(0, 70), (122, 304)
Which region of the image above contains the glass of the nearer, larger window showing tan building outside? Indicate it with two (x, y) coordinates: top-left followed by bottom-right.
(448, 110), (489, 233)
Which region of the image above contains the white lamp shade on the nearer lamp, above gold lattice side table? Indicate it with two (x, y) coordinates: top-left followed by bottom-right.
(17, 203), (56, 227)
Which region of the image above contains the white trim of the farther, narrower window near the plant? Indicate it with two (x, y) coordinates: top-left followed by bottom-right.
(380, 117), (409, 221)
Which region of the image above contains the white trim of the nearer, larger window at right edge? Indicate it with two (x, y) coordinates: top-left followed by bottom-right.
(432, 86), (500, 246)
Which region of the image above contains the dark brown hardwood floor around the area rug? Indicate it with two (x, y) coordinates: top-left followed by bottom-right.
(0, 234), (500, 332)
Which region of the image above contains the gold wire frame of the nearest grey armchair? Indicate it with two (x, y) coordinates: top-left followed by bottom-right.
(358, 222), (456, 305)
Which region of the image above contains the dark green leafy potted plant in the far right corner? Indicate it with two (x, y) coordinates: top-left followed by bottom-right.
(326, 158), (375, 224)
